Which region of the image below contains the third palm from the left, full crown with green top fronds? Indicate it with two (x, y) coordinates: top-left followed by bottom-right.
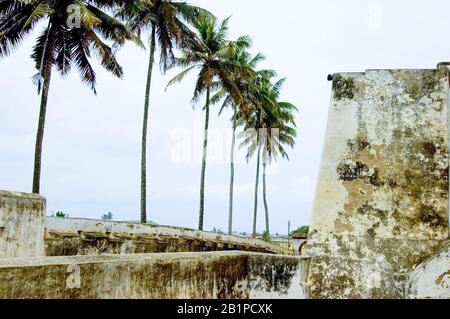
(168, 15), (249, 230)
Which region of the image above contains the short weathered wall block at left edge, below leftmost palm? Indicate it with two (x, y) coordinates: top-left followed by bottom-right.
(0, 191), (46, 258)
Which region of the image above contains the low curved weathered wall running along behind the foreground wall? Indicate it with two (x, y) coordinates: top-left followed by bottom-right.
(45, 217), (293, 256)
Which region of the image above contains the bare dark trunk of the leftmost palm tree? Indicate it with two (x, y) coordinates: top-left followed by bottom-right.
(33, 66), (52, 194)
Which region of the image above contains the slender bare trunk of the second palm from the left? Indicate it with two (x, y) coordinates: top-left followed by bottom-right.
(141, 27), (156, 224)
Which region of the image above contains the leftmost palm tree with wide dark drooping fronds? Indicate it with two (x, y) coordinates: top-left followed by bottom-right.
(0, 0), (139, 193)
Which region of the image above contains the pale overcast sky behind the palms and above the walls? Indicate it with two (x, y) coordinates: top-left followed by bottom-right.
(0, 0), (450, 233)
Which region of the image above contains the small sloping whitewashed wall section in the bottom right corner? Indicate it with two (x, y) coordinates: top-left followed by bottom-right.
(406, 242), (450, 299)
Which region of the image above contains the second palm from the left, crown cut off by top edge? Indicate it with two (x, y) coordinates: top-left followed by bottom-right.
(117, 0), (212, 223)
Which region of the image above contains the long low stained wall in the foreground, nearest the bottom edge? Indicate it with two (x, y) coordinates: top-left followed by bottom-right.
(0, 252), (303, 299)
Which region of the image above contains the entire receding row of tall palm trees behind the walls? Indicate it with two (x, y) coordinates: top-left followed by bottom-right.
(0, 0), (297, 240)
